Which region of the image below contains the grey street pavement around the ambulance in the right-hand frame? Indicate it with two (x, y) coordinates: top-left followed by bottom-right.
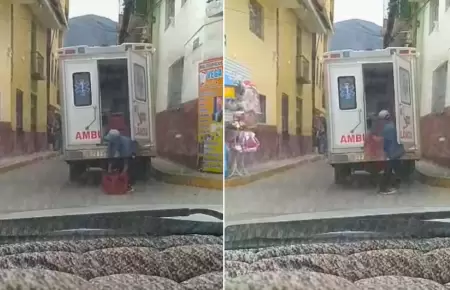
(225, 160), (450, 221)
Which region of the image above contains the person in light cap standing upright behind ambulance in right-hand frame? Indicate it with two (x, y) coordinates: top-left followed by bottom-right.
(378, 110), (405, 194)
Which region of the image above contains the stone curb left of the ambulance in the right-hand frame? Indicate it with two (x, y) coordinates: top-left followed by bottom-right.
(225, 155), (325, 188)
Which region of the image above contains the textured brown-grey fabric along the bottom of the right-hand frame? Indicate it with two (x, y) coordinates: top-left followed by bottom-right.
(225, 238), (450, 290)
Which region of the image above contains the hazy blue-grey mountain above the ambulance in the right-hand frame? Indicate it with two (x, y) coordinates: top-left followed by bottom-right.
(329, 19), (383, 50)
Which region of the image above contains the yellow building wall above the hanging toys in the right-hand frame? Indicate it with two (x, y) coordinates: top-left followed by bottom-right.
(225, 0), (312, 135)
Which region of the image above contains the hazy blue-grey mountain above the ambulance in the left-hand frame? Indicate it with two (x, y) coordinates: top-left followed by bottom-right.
(64, 15), (117, 46)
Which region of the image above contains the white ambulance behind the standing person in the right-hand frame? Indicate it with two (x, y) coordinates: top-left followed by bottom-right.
(324, 47), (420, 183)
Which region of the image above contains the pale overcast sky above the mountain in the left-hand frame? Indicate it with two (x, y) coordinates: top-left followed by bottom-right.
(69, 0), (120, 22)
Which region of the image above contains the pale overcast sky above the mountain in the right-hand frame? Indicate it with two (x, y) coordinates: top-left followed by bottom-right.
(334, 0), (385, 26)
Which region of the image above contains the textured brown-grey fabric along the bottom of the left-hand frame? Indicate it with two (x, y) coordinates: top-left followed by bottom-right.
(0, 235), (223, 290)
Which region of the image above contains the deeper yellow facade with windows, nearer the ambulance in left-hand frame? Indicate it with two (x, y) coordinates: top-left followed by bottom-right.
(11, 5), (47, 132)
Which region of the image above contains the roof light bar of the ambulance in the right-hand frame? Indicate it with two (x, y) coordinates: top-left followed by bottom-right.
(323, 47), (417, 60)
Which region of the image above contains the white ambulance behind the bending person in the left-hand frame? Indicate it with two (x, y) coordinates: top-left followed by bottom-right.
(58, 43), (156, 180)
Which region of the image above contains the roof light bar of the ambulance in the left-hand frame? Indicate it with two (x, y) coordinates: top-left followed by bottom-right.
(58, 43), (155, 56)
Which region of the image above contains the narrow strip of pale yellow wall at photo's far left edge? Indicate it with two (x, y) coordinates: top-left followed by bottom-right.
(0, 0), (11, 122)
